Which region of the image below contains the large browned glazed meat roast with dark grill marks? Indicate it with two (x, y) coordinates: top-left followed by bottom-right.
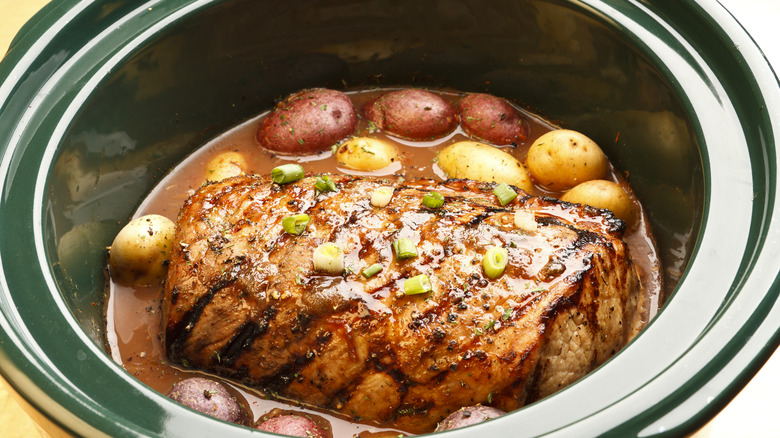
(163, 176), (639, 433)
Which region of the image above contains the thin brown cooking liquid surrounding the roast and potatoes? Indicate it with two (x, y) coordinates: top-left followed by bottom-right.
(106, 89), (662, 438)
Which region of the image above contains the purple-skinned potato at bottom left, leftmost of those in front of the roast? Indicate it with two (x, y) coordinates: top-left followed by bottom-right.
(168, 377), (251, 426)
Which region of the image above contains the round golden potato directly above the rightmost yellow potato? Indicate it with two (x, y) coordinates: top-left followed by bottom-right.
(526, 129), (609, 190)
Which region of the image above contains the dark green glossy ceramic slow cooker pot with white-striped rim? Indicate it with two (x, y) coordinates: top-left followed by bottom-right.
(0, 0), (780, 437)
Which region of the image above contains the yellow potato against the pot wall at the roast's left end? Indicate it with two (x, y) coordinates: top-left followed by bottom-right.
(109, 214), (176, 286)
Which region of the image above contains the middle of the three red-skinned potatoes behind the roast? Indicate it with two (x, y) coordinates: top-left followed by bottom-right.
(363, 88), (458, 141)
